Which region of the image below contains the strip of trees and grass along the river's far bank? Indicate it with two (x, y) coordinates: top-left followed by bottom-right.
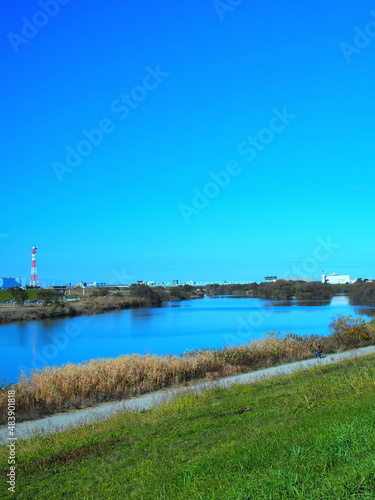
(0, 280), (375, 324)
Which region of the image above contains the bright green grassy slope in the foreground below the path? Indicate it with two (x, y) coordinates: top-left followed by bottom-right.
(1, 356), (375, 500)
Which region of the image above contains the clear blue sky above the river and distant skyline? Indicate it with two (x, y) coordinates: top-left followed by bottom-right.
(0, 0), (375, 283)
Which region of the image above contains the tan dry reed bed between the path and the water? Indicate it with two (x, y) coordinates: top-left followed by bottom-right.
(0, 333), (373, 424)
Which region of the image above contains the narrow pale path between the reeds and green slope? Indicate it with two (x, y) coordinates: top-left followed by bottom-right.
(0, 346), (375, 444)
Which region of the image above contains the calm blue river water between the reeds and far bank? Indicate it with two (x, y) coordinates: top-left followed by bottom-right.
(0, 296), (375, 382)
